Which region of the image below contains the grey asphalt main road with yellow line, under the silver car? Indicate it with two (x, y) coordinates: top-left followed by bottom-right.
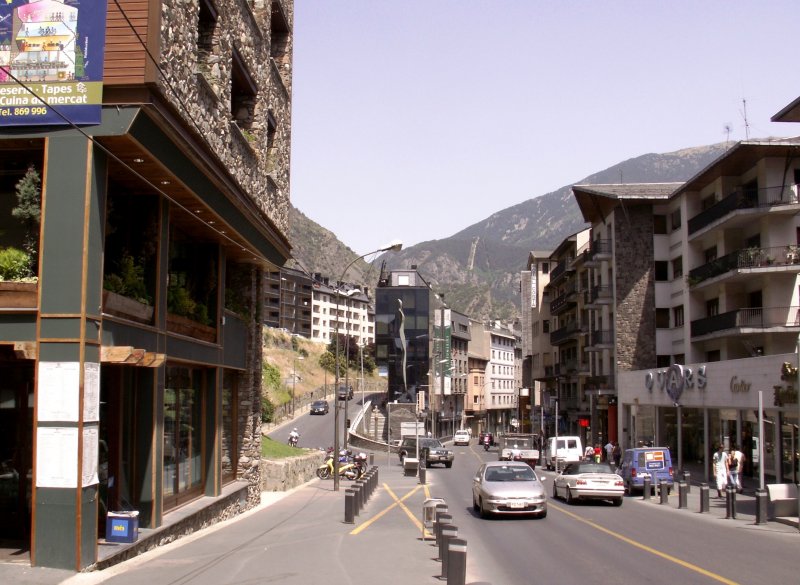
(428, 441), (800, 585)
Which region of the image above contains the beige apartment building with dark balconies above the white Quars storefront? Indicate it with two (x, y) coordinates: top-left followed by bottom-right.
(573, 133), (800, 481)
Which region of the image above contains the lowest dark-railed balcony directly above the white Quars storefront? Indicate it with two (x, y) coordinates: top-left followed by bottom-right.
(691, 306), (800, 339)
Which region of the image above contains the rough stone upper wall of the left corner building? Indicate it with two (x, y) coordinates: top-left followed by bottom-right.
(158, 0), (294, 237)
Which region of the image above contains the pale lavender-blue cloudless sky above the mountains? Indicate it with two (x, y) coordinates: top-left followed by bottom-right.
(290, 0), (800, 254)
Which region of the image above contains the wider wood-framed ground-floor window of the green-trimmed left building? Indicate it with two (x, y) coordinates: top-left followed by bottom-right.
(162, 366), (204, 509)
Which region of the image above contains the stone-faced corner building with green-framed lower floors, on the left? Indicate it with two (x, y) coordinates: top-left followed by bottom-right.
(0, 0), (293, 571)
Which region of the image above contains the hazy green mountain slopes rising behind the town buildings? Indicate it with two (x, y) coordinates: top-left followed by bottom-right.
(291, 143), (729, 319)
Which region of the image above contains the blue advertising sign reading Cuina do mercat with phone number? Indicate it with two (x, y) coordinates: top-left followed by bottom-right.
(0, 0), (106, 126)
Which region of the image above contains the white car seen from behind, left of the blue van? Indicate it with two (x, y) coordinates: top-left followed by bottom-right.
(553, 461), (625, 506)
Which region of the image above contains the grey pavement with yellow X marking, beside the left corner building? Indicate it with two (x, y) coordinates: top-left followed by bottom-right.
(0, 466), (450, 585)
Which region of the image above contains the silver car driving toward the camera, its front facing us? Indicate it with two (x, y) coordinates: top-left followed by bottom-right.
(472, 461), (547, 518)
